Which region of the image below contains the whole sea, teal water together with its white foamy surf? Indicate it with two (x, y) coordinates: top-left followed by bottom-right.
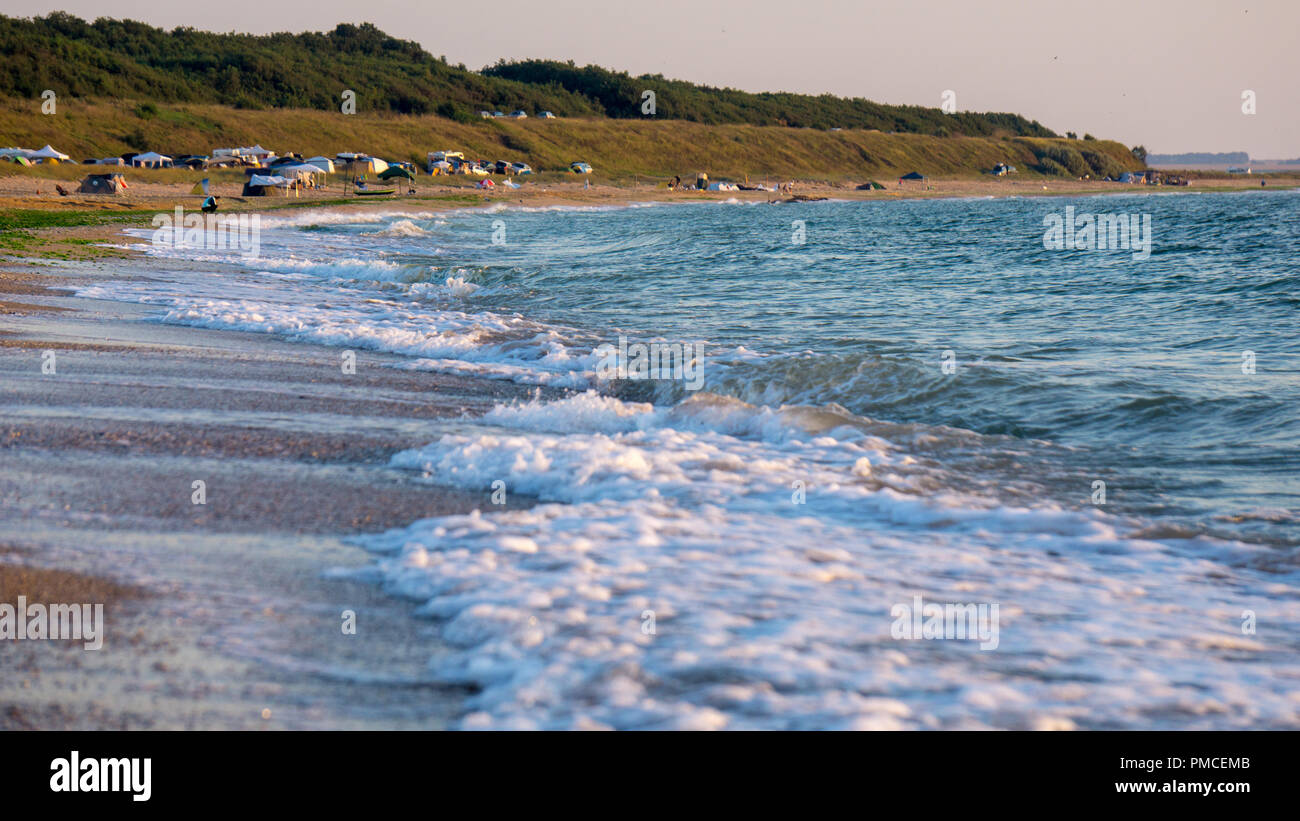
(82, 191), (1300, 729)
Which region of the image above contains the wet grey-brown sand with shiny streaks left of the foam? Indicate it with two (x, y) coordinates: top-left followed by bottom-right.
(0, 259), (551, 729)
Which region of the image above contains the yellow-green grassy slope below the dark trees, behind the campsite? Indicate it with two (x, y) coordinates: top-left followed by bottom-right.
(0, 99), (1140, 182)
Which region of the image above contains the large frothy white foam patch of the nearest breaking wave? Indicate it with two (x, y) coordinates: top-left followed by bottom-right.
(360, 394), (1300, 729)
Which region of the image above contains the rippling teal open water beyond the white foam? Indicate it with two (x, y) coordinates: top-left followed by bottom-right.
(306, 191), (1300, 544)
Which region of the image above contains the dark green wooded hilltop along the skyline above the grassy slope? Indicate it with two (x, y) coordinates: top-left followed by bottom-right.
(0, 13), (1056, 136)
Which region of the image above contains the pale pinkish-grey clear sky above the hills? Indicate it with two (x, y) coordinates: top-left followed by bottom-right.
(0, 0), (1300, 160)
